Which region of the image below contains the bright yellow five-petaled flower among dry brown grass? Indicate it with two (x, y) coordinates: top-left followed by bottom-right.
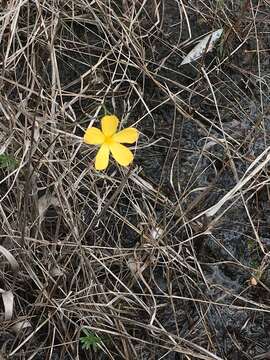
(83, 115), (139, 170)
